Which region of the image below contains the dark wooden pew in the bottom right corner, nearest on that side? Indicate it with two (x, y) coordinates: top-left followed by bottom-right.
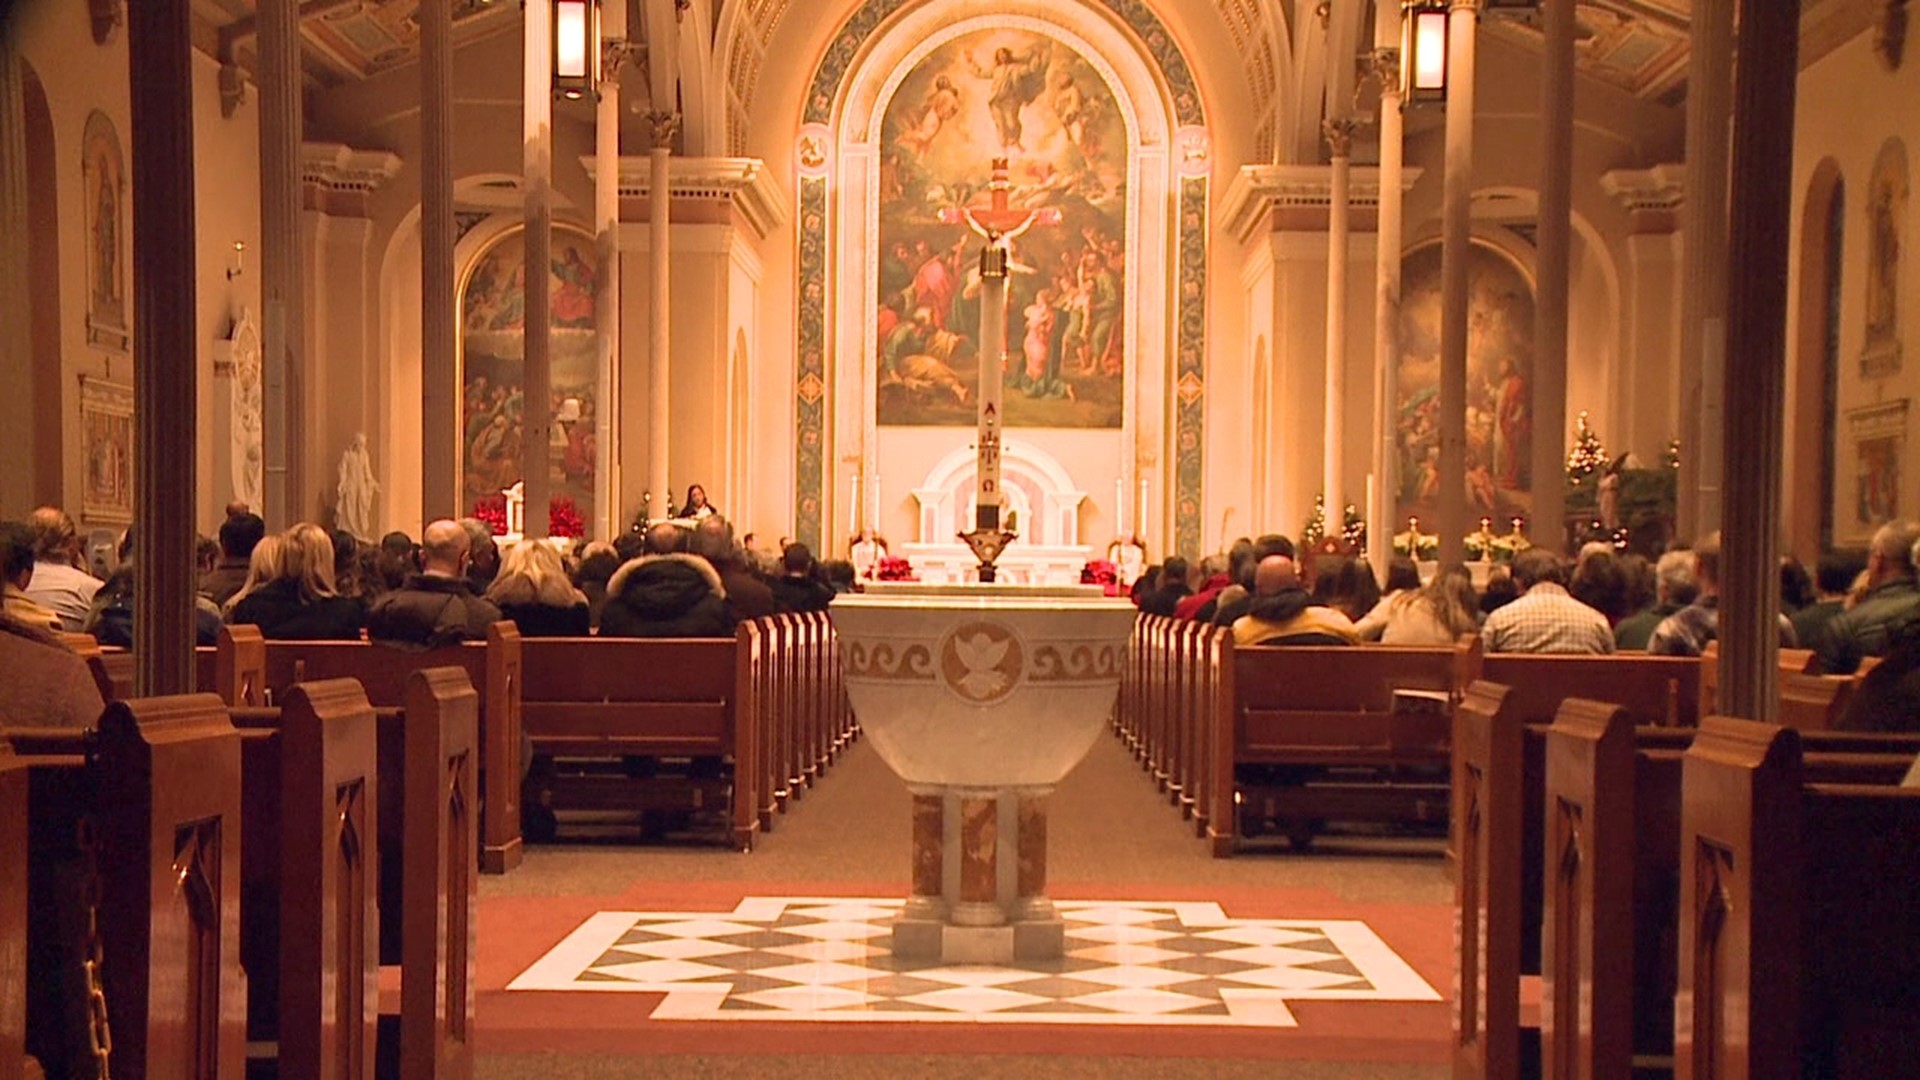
(1674, 717), (1920, 1080)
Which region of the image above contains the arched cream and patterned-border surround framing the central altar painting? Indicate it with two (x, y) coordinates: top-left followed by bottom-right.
(795, 0), (1210, 546)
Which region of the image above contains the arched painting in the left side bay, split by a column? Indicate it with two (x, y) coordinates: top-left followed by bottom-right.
(461, 229), (599, 521)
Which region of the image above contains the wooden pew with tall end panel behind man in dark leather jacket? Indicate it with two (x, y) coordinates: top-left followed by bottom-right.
(215, 621), (524, 874)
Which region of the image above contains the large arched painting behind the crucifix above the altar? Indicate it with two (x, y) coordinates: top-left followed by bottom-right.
(876, 29), (1129, 429)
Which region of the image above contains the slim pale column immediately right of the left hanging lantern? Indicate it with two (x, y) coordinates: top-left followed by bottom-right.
(593, 4), (626, 540)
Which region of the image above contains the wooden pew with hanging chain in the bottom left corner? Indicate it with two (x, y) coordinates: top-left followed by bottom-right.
(12, 696), (246, 1076)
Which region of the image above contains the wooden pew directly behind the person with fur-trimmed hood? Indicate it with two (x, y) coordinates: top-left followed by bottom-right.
(520, 630), (756, 851)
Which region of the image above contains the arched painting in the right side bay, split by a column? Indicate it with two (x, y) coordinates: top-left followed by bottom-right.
(1394, 244), (1553, 532)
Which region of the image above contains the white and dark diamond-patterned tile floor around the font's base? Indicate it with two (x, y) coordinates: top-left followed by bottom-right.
(507, 897), (1440, 1028)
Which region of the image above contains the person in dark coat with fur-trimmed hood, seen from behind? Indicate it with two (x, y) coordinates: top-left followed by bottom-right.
(601, 523), (733, 638)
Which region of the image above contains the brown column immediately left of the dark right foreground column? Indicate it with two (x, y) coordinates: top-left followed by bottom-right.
(1678, 0), (1743, 538)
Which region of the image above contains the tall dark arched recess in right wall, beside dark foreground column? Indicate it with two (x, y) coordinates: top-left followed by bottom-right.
(1788, 158), (1847, 559)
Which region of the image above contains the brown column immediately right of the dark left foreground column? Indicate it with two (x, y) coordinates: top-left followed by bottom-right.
(261, 0), (307, 530)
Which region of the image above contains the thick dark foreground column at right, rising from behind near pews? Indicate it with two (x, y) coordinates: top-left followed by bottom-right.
(1728, 0), (1801, 721)
